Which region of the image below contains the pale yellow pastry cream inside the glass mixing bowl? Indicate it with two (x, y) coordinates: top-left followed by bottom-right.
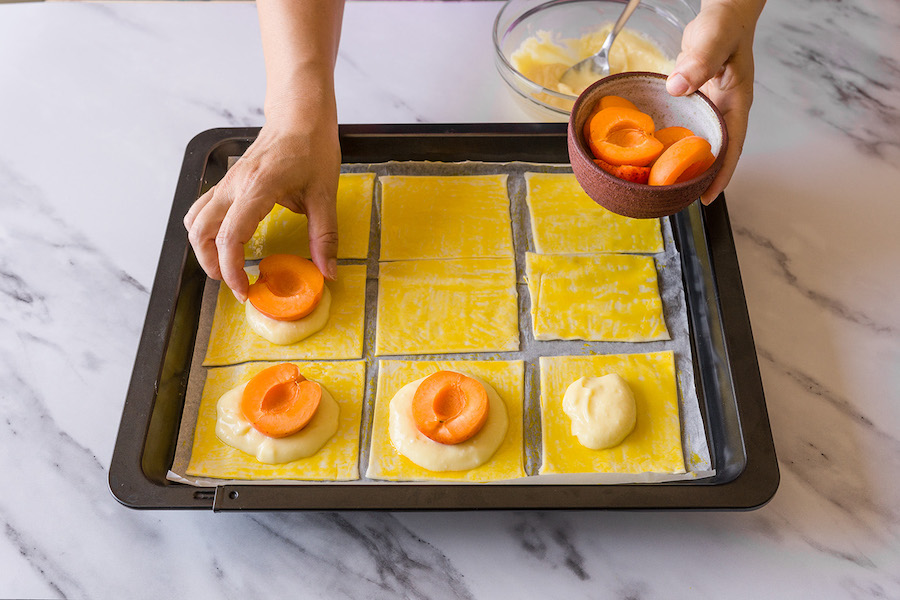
(509, 23), (675, 96)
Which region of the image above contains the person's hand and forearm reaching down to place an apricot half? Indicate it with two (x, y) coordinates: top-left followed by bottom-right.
(184, 0), (344, 302)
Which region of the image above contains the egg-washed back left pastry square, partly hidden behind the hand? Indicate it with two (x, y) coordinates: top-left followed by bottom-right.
(244, 173), (375, 260)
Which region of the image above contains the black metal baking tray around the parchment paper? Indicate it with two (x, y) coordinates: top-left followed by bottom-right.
(109, 123), (779, 511)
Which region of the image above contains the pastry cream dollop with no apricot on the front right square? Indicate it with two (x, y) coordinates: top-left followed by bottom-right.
(562, 373), (637, 450)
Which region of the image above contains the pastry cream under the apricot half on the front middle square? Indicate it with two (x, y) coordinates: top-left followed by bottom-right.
(388, 373), (509, 471)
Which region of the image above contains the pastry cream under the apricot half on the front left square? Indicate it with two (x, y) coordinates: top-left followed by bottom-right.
(216, 380), (341, 464)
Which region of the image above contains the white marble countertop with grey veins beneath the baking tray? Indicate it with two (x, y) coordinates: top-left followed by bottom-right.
(0, 0), (900, 599)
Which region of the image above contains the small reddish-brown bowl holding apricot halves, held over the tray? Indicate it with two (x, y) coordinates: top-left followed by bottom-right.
(568, 71), (728, 219)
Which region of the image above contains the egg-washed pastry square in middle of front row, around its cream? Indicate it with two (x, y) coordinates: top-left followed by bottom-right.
(366, 360), (525, 482)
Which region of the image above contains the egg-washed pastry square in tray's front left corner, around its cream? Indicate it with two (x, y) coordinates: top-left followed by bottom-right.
(186, 361), (366, 481)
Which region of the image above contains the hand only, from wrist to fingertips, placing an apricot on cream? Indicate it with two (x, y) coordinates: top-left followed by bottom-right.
(184, 111), (341, 302)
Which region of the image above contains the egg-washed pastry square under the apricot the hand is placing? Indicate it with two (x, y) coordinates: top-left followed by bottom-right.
(203, 265), (366, 367)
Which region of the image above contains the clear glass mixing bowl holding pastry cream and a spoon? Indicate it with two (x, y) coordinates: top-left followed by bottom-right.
(493, 0), (697, 119)
